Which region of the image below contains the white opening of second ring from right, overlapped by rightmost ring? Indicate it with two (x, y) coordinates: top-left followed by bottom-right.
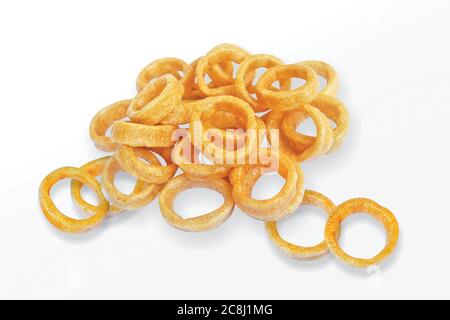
(277, 205), (328, 247)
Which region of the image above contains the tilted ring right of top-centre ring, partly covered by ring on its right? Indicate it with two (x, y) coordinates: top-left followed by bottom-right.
(235, 54), (291, 112)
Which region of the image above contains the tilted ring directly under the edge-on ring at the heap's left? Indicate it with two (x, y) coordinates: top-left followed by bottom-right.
(116, 145), (177, 184)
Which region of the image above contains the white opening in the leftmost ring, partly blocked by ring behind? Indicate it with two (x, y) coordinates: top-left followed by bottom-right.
(50, 179), (93, 220)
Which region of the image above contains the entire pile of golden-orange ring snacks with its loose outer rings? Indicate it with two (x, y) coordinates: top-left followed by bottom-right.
(39, 44), (399, 267)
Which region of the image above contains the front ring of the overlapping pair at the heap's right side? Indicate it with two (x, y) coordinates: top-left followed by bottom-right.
(266, 105), (333, 162)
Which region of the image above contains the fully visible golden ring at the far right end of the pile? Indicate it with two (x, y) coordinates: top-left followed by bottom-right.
(325, 198), (399, 268)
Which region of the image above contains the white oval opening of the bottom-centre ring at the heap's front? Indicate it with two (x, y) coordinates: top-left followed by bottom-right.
(173, 188), (224, 219)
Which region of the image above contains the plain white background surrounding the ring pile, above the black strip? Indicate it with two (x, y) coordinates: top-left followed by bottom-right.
(0, 0), (450, 299)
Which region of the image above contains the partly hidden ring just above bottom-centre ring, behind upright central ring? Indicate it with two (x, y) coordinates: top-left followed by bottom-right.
(172, 137), (232, 180)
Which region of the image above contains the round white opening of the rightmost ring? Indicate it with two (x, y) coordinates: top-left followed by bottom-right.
(339, 213), (386, 259)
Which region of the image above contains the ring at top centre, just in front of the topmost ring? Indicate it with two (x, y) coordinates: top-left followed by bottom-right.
(195, 47), (249, 96)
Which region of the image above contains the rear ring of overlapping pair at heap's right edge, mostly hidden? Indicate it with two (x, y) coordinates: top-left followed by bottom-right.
(280, 95), (349, 153)
